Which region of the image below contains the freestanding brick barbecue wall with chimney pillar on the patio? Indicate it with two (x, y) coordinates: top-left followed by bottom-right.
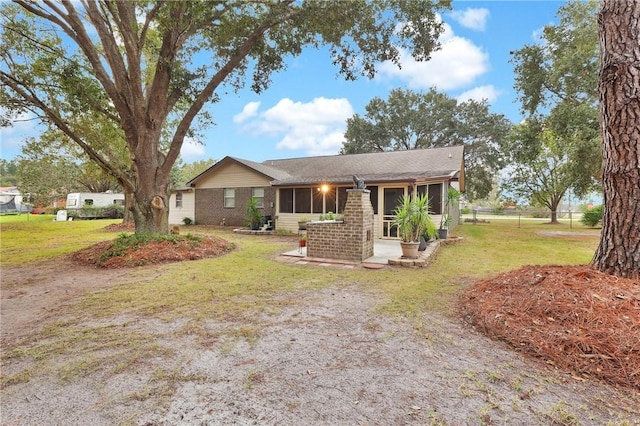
(307, 189), (373, 262)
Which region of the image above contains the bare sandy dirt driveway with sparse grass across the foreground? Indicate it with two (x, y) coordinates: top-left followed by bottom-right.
(0, 260), (640, 425)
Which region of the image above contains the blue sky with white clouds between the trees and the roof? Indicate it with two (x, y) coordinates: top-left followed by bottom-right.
(0, 0), (564, 162)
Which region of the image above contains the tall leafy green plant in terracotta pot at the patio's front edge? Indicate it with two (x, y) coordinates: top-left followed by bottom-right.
(394, 194), (436, 259)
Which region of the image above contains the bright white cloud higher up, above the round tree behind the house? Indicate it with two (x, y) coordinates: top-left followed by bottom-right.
(380, 23), (489, 90)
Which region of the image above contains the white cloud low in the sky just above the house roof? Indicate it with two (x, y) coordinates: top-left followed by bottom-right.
(238, 97), (353, 155)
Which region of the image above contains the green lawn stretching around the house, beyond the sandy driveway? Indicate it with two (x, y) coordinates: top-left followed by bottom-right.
(0, 215), (598, 316)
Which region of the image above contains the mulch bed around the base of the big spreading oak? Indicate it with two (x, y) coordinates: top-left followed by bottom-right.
(71, 224), (235, 268)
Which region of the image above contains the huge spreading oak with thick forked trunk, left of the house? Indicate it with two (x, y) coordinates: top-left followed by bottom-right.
(0, 0), (450, 233)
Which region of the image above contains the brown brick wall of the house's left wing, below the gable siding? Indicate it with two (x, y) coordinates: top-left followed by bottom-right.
(195, 187), (276, 226)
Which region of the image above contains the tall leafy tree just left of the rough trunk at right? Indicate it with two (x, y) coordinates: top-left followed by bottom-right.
(509, 0), (601, 201)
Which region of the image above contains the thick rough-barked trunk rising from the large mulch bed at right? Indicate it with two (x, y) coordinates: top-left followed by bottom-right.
(593, 0), (640, 278)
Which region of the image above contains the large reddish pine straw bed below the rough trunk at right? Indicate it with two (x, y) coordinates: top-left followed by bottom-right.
(459, 266), (640, 389)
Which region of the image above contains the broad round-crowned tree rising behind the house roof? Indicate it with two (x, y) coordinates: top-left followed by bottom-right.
(341, 88), (511, 200)
